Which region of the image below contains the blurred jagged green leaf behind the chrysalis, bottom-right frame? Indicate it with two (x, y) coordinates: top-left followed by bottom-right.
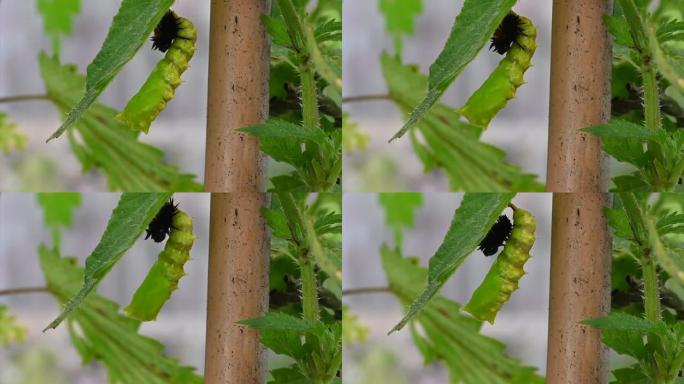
(380, 245), (545, 384)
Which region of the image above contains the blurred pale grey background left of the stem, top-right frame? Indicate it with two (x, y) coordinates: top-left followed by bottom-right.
(343, 0), (552, 191)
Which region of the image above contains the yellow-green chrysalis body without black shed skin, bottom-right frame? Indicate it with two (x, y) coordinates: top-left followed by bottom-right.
(463, 207), (537, 324)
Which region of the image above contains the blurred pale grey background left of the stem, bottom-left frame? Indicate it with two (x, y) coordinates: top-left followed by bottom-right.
(0, 192), (209, 384)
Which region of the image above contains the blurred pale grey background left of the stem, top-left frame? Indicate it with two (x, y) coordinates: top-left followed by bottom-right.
(0, 0), (209, 191)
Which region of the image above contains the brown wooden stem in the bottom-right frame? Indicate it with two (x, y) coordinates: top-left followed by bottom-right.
(546, 192), (612, 384)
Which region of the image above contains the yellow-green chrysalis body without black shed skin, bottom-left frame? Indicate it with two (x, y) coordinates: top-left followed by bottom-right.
(125, 210), (195, 321)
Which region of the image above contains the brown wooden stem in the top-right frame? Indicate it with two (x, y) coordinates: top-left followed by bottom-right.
(546, 0), (613, 192)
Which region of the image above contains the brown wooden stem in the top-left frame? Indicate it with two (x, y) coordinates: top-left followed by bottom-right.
(204, 0), (271, 192)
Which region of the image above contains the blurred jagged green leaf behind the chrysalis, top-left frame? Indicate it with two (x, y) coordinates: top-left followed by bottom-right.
(38, 52), (202, 192)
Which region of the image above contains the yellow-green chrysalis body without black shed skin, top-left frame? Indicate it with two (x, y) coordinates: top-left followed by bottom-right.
(116, 13), (197, 133)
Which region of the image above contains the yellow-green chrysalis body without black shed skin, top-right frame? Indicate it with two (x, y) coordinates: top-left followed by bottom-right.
(458, 16), (537, 128)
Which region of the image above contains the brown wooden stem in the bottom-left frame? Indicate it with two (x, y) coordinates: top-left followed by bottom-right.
(204, 192), (271, 384)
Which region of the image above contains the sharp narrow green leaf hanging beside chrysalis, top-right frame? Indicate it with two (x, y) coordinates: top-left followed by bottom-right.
(390, 0), (516, 141)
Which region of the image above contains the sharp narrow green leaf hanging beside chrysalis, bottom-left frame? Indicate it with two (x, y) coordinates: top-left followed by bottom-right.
(45, 193), (171, 330)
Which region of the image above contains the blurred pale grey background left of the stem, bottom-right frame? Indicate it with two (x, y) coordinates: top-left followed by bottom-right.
(343, 193), (551, 384)
